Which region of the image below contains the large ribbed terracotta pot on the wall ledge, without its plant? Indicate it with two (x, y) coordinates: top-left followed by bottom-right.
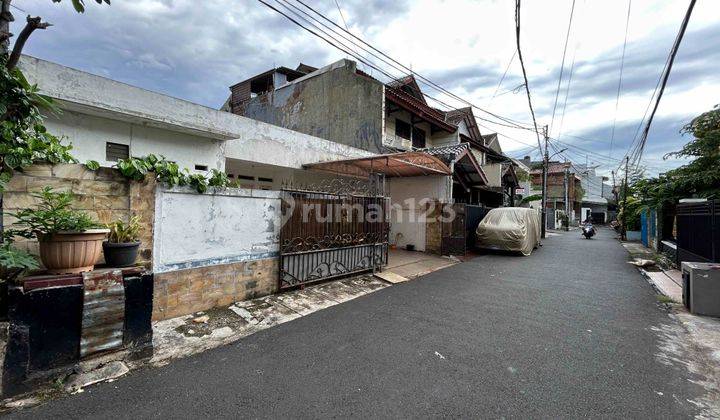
(38, 229), (110, 274)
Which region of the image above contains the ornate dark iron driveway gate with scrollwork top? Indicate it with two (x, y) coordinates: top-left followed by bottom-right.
(280, 175), (389, 289)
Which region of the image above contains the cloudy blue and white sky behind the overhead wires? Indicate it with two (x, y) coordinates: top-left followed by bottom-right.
(13, 0), (720, 173)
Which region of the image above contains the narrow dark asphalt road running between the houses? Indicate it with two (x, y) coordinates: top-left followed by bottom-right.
(9, 229), (703, 418)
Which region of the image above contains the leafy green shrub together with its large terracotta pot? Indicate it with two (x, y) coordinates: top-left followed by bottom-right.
(11, 187), (109, 274)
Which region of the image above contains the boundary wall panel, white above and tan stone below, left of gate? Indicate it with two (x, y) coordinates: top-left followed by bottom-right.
(153, 188), (280, 320)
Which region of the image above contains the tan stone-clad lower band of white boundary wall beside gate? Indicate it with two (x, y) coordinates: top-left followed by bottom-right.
(153, 258), (279, 321)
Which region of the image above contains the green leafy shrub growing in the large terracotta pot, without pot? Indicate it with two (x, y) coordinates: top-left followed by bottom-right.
(9, 187), (101, 239)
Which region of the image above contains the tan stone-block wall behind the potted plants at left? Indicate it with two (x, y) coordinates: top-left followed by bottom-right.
(2, 164), (130, 255)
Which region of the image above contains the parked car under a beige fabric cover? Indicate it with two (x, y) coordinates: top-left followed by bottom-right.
(475, 207), (540, 255)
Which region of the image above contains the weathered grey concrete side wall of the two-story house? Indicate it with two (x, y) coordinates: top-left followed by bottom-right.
(235, 60), (384, 153)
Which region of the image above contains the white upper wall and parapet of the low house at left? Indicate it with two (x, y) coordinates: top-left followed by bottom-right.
(21, 56), (372, 170)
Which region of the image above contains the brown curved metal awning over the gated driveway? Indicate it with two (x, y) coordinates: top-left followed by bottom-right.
(303, 152), (452, 178)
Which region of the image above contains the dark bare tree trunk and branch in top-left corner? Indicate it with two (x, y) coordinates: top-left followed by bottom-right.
(0, 0), (110, 70)
